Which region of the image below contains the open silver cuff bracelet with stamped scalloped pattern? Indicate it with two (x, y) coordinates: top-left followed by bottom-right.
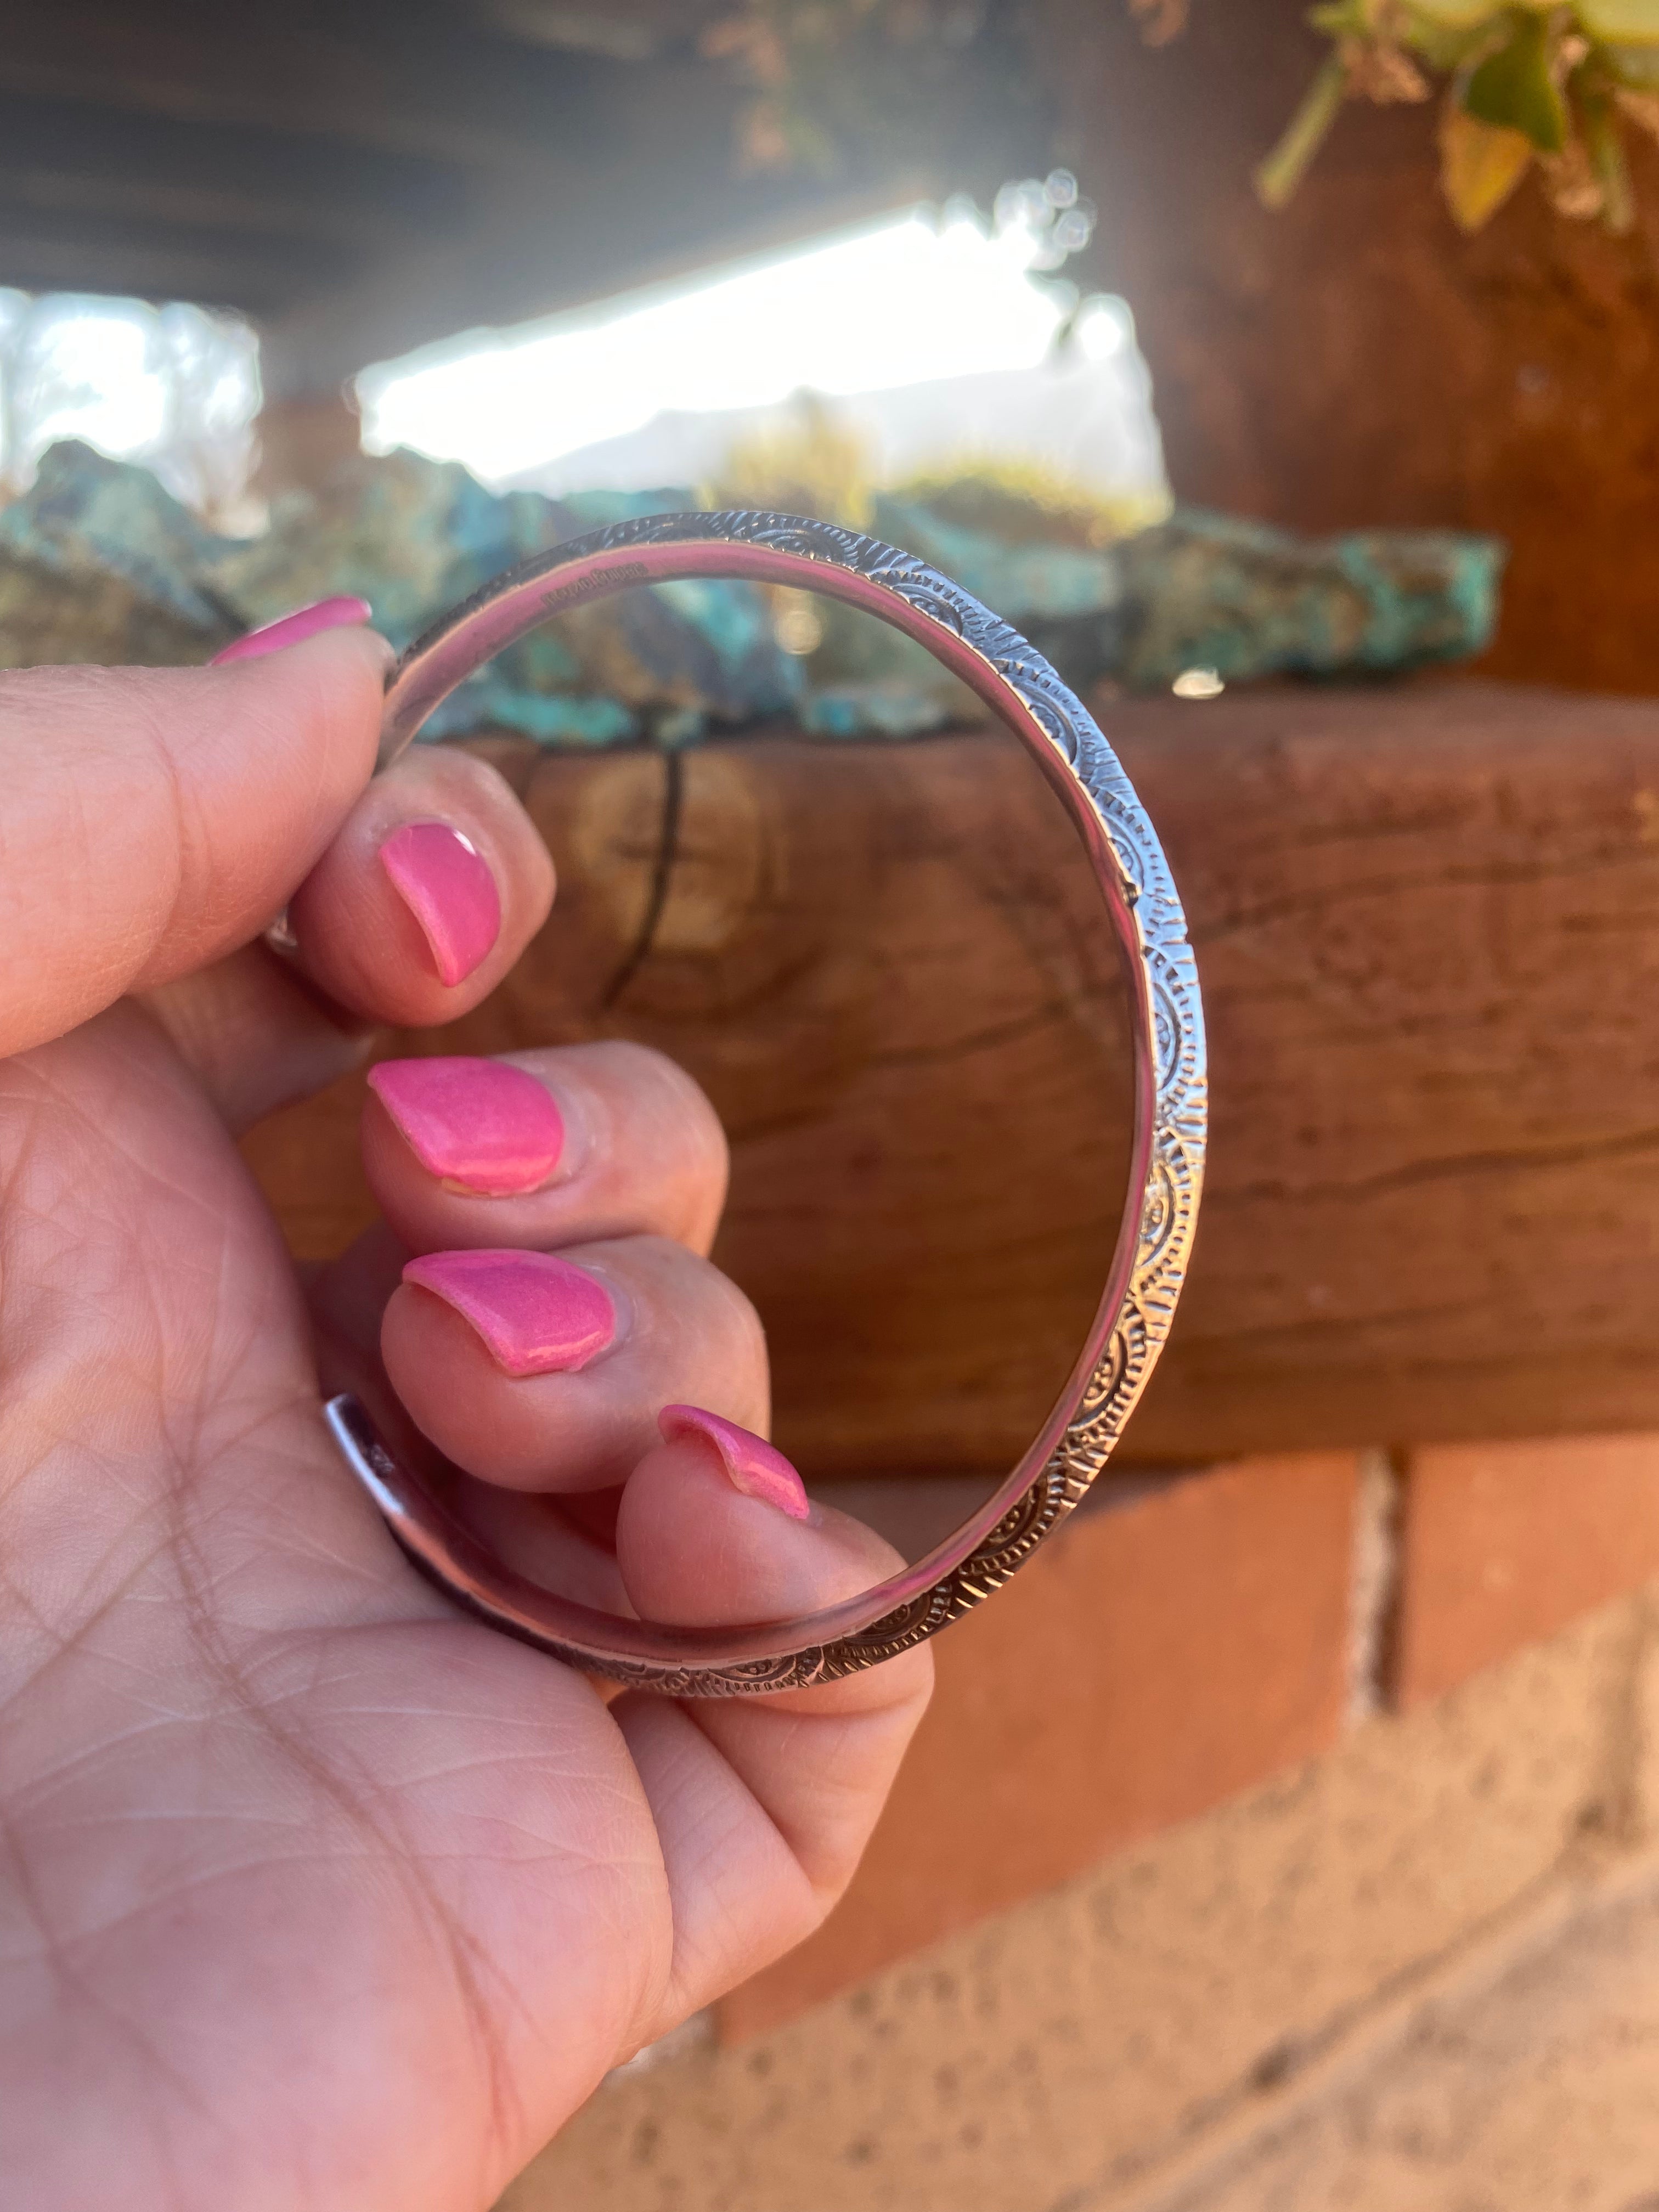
(328, 513), (1205, 1697)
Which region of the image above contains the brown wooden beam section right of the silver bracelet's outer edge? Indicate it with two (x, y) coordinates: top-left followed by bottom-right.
(1121, 684), (1659, 1453)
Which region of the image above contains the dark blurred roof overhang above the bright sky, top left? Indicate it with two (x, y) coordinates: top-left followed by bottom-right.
(0, 0), (1046, 374)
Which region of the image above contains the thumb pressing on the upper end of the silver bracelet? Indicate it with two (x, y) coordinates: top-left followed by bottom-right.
(0, 630), (392, 1057)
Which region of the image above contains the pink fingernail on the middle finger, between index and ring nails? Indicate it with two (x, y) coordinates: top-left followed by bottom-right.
(369, 1057), (564, 1199)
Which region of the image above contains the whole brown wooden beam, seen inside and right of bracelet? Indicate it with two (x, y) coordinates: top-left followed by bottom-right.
(236, 684), (1659, 1473)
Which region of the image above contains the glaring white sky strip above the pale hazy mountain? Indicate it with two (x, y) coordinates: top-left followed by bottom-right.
(358, 210), (1066, 482)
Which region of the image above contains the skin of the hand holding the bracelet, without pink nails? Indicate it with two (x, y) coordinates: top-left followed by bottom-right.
(0, 628), (931, 2212)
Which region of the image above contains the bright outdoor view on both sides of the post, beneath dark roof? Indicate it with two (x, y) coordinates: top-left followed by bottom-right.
(0, 170), (1168, 522)
